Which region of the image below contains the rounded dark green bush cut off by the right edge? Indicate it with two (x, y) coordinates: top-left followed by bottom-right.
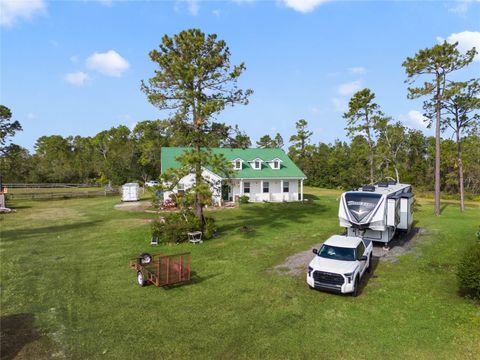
(457, 241), (480, 299)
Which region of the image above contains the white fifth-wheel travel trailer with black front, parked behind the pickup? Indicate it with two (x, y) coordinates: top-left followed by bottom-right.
(338, 182), (413, 244)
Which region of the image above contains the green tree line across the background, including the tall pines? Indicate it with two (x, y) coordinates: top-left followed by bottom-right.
(0, 29), (480, 221)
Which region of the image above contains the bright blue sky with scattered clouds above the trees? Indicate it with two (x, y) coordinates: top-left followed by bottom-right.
(0, 0), (480, 150)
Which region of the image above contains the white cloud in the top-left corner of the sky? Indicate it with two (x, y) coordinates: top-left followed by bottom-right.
(0, 0), (46, 26)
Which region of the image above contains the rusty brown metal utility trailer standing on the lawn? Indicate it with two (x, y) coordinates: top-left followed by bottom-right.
(130, 253), (190, 286)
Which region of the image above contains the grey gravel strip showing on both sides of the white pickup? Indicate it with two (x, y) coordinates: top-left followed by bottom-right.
(270, 228), (428, 276)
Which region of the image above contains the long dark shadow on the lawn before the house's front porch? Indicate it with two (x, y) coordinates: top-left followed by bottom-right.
(219, 202), (327, 236)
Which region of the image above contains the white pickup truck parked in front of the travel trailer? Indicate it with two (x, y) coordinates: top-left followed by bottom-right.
(307, 235), (373, 296)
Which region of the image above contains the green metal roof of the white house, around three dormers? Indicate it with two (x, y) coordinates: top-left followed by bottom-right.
(161, 147), (306, 179)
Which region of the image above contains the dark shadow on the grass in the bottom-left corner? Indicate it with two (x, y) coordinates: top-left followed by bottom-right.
(0, 314), (40, 360)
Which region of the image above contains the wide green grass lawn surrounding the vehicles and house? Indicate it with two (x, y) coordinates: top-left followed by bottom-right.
(0, 188), (480, 359)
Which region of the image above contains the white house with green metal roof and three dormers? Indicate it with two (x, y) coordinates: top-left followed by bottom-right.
(161, 147), (306, 205)
